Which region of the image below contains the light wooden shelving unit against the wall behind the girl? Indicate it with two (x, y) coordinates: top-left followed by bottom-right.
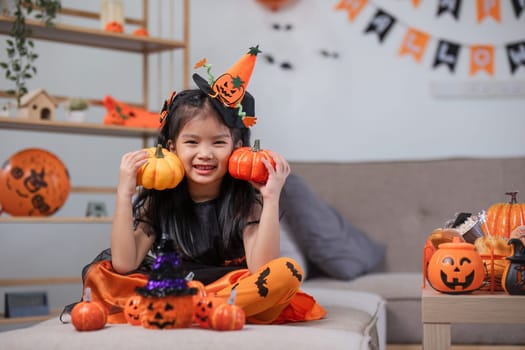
(0, 0), (190, 325)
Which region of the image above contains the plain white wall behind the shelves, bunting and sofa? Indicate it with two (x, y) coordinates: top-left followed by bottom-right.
(0, 0), (525, 326)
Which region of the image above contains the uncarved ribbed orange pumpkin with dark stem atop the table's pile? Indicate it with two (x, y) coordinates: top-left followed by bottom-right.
(483, 191), (525, 238)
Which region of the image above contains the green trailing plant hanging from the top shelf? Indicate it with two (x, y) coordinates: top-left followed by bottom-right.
(0, 0), (62, 107)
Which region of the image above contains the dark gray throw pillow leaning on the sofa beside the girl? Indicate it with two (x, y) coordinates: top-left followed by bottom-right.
(280, 173), (385, 280)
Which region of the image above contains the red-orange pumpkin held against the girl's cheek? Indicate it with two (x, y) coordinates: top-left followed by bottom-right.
(228, 140), (275, 183)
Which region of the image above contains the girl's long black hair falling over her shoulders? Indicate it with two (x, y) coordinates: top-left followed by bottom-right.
(133, 89), (261, 259)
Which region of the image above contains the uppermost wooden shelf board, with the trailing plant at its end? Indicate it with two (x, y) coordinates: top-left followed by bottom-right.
(0, 16), (186, 54)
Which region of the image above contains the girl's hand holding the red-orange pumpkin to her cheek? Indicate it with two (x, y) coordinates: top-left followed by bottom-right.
(251, 151), (290, 199)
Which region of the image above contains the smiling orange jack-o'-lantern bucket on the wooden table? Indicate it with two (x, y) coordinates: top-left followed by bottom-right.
(427, 238), (485, 293)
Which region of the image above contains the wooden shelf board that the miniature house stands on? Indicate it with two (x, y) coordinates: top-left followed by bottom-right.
(0, 117), (158, 138)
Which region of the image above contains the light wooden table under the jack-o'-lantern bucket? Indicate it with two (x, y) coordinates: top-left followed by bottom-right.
(421, 287), (525, 350)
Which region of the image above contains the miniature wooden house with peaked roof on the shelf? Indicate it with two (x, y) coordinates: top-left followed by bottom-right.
(18, 89), (57, 120)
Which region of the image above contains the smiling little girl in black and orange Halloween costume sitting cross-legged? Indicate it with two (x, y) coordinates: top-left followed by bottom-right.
(81, 48), (326, 323)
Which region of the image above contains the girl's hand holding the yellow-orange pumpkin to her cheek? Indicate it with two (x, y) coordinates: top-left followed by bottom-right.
(117, 149), (149, 197)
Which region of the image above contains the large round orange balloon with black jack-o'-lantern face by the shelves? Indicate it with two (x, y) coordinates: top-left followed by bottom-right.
(0, 148), (71, 216)
